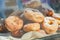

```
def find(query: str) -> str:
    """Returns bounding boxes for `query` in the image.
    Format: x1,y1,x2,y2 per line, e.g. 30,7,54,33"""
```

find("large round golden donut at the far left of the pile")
5,16,23,32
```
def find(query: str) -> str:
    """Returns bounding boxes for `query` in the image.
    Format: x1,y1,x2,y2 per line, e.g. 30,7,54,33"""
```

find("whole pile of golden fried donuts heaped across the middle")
5,8,60,37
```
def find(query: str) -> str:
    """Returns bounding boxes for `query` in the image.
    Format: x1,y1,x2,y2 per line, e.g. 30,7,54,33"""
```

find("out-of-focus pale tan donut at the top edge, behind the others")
24,0,41,8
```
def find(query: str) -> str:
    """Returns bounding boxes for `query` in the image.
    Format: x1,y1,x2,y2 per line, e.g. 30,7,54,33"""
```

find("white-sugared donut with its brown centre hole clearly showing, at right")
42,17,58,34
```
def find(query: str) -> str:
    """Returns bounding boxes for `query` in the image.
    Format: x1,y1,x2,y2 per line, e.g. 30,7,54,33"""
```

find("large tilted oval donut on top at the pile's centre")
24,8,44,23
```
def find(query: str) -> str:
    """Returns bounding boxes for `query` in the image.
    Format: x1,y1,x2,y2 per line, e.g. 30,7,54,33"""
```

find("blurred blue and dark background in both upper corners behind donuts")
0,0,60,18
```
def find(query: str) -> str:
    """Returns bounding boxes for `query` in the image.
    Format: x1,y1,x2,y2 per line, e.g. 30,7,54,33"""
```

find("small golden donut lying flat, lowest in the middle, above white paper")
23,23,40,32
